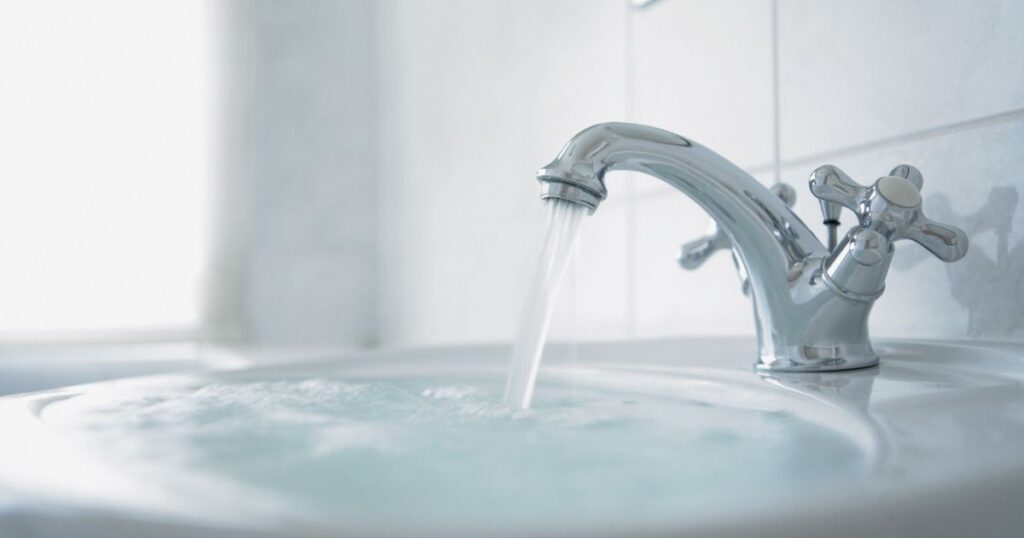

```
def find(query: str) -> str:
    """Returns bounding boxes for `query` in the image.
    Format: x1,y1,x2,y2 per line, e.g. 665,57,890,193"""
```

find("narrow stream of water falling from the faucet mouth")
505,200,587,409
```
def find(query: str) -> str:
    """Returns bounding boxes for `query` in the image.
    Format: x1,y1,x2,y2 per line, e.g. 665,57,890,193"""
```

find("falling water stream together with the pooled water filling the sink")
6,189,868,536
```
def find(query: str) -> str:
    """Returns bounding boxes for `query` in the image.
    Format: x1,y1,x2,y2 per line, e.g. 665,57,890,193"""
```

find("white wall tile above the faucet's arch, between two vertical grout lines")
631,0,773,192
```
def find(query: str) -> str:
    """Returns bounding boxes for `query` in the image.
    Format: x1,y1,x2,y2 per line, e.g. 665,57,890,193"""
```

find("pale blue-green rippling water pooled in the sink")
28,368,864,534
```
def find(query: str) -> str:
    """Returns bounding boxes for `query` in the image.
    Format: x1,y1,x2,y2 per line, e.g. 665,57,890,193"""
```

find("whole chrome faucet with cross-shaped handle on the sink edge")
537,123,968,372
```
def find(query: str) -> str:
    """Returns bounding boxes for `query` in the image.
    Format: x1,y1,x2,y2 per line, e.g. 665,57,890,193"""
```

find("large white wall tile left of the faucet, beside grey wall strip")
380,0,627,344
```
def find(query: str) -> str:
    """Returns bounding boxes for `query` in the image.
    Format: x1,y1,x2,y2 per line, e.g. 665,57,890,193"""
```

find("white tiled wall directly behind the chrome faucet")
378,0,1024,345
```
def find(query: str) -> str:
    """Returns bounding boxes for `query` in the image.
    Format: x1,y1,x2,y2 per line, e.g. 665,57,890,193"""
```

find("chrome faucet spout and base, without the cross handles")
537,123,878,371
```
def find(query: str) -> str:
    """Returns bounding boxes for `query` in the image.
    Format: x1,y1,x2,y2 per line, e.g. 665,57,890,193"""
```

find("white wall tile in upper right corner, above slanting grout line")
778,0,1024,160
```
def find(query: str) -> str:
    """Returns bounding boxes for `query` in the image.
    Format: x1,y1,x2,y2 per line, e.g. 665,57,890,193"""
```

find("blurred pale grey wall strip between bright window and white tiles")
214,0,378,345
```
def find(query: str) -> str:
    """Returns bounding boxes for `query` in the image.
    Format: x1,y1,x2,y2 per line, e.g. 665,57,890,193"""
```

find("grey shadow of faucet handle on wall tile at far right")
893,187,1024,338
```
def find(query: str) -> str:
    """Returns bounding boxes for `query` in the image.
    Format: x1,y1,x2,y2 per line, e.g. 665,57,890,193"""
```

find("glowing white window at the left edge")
0,0,214,339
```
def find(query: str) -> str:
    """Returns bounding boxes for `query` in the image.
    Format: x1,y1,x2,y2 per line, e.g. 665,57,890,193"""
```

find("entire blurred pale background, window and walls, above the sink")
0,0,1024,358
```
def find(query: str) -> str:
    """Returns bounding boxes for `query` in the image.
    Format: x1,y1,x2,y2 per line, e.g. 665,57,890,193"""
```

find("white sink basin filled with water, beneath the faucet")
0,339,1024,536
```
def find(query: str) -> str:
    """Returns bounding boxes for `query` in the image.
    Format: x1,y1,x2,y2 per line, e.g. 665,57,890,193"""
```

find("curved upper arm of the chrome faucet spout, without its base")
538,123,827,291
